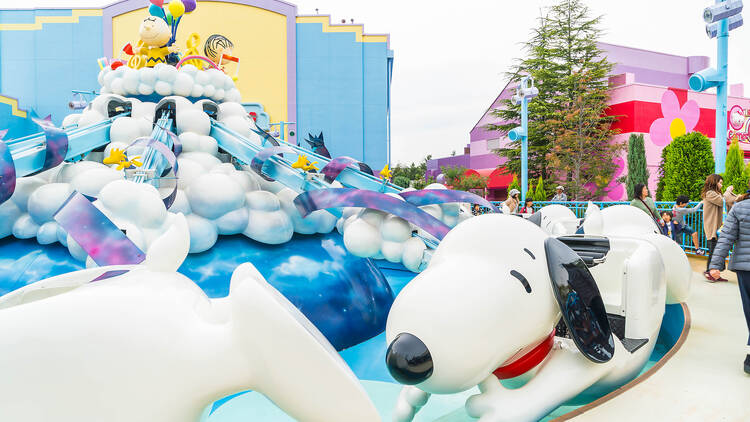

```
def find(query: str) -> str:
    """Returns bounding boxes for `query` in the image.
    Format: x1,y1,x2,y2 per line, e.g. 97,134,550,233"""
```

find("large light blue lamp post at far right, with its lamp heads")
688,0,743,174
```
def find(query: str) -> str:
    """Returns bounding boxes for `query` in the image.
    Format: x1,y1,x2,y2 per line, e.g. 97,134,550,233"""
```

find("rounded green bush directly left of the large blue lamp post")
660,132,714,201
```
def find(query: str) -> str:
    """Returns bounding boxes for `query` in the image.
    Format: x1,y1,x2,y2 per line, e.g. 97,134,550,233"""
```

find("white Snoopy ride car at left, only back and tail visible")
0,214,380,422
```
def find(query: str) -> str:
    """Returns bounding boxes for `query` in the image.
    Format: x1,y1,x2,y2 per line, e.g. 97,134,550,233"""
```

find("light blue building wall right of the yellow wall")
297,23,390,170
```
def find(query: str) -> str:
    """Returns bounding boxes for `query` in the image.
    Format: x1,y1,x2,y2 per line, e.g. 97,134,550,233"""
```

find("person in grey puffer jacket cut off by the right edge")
708,190,750,374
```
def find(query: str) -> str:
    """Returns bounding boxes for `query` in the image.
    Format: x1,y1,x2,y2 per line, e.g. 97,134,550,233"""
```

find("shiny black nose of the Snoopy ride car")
385,333,433,385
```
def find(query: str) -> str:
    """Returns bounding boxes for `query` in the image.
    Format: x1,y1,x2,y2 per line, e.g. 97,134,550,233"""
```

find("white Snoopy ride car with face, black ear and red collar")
386,207,690,422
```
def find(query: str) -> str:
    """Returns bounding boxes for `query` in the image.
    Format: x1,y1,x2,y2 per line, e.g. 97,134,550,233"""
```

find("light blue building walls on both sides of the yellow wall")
0,9,392,170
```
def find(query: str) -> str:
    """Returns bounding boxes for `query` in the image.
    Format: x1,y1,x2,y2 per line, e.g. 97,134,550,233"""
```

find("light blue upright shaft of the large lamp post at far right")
714,11,729,174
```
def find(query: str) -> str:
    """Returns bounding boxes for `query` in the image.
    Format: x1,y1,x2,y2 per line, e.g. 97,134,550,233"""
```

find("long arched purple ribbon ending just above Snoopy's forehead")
294,188,450,240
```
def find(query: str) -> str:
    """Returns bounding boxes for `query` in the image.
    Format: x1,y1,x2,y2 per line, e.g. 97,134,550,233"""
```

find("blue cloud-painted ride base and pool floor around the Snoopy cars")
0,233,684,422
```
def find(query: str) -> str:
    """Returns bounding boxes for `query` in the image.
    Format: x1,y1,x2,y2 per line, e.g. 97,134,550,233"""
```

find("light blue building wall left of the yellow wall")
0,9,103,136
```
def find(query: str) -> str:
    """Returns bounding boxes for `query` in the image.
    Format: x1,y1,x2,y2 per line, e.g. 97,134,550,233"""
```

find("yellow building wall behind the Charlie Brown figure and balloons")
112,1,288,122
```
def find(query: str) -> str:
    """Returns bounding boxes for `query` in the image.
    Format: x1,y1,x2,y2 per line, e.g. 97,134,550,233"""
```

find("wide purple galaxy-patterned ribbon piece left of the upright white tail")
55,192,146,266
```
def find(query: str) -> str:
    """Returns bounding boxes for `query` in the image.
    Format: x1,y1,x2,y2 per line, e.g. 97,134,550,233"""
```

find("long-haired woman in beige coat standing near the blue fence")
701,174,737,283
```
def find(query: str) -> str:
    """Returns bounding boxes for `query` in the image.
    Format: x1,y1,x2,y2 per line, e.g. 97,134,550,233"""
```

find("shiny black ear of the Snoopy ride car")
544,237,615,363
